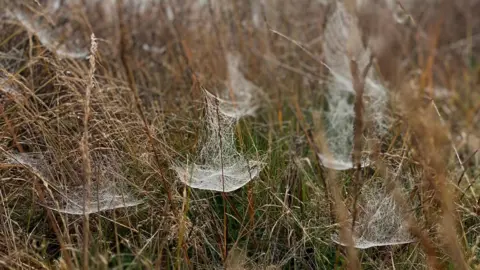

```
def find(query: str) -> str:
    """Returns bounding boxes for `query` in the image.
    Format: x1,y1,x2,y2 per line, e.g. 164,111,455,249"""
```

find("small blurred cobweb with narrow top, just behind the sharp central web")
217,53,259,119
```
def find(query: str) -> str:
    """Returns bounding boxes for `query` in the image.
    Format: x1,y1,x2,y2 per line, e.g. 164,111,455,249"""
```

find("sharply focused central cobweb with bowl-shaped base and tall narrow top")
173,91,265,192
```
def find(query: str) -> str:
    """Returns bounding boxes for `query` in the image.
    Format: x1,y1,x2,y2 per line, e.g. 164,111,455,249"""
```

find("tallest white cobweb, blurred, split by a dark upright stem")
319,2,387,170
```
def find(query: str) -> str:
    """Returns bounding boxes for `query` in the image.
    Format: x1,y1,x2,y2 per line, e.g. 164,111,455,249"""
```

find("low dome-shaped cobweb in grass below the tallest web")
332,183,416,249
